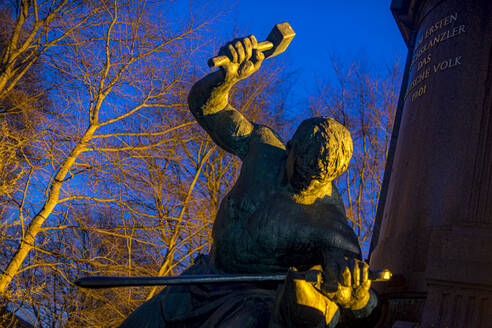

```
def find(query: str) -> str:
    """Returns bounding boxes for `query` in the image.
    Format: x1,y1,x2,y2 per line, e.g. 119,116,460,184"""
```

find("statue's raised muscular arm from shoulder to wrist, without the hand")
188,70,253,159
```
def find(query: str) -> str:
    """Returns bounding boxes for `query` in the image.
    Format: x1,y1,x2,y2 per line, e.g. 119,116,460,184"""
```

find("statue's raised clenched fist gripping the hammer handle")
219,35,265,83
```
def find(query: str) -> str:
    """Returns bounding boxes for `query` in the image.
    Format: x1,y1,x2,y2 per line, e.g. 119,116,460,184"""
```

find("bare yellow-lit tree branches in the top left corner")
0,0,104,99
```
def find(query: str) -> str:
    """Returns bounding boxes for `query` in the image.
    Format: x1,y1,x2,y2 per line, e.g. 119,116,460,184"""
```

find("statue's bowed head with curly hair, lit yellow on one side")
286,117,353,192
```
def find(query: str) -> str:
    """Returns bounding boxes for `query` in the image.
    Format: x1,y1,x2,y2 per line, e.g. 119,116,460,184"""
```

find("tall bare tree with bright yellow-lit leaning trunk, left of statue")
0,1,212,293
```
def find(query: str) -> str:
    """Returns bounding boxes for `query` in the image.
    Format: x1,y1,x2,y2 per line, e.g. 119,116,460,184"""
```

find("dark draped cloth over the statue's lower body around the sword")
120,255,277,328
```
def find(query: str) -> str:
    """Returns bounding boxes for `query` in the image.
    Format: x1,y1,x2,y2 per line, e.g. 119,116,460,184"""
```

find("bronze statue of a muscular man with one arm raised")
121,26,377,328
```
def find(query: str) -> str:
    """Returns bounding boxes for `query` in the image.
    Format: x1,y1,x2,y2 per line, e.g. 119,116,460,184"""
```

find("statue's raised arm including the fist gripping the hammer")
188,35,264,159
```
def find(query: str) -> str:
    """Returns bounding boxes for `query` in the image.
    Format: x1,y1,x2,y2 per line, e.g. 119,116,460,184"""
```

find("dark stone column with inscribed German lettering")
371,0,492,327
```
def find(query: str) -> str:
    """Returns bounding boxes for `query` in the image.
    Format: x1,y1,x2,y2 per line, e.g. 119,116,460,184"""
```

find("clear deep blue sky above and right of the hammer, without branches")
193,0,407,105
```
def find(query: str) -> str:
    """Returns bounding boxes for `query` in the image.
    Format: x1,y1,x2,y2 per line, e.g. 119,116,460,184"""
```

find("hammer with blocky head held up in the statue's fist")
208,22,296,68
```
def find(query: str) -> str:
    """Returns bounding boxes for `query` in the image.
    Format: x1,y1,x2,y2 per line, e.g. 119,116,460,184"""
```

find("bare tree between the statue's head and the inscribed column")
310,59,401,250
